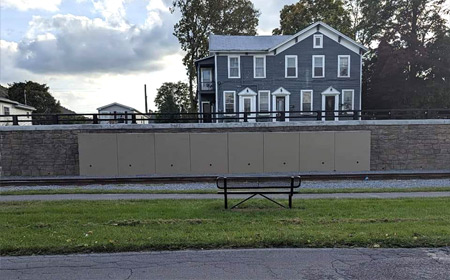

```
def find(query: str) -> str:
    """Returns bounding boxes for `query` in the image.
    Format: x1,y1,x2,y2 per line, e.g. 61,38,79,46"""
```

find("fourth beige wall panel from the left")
190,133,228,174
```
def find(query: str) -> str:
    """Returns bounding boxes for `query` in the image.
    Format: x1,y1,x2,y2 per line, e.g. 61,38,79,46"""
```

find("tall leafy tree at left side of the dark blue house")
172,0,260,112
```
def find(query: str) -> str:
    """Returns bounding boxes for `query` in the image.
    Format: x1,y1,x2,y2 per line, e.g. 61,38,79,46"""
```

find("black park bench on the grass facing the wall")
216,176,302,209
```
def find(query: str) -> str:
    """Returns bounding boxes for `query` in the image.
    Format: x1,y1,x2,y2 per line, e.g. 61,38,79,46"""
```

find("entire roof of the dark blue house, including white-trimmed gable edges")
209,21,368,52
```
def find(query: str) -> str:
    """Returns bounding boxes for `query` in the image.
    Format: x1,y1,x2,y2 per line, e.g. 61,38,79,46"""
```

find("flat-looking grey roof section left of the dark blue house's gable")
209,35,291,52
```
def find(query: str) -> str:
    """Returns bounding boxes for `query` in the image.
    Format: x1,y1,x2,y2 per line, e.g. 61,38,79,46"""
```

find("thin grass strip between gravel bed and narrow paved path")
0,186,450,195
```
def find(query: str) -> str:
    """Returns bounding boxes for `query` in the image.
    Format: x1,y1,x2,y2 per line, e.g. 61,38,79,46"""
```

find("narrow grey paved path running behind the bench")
0,192,450,202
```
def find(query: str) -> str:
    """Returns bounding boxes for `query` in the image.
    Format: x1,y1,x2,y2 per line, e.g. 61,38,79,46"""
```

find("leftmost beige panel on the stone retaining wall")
78,133,118,176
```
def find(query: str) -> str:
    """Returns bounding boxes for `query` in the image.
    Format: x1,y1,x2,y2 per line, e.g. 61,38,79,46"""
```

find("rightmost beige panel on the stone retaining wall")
334,131,370,172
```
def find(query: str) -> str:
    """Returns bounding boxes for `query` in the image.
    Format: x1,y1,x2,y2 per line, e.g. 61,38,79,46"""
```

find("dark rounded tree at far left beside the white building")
8,81,61,114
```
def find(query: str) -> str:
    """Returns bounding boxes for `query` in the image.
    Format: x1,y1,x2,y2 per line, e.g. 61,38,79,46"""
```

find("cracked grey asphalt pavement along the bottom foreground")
0,248,450,280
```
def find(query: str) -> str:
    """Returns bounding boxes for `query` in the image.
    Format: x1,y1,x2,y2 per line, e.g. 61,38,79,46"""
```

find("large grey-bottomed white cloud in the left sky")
17,0,180,74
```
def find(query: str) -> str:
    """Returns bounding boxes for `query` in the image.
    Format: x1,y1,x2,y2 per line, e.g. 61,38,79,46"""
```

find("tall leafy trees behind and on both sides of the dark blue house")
160,0,450,112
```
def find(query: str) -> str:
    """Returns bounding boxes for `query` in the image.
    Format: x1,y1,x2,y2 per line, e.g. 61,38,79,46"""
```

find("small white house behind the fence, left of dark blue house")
97,102,149,124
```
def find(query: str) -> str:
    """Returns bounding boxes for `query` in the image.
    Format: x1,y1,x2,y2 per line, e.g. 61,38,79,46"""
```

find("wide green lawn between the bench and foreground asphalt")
0,198,450,255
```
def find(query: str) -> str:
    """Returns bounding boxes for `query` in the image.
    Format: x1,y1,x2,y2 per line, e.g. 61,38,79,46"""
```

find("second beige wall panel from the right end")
300,131,334,171
